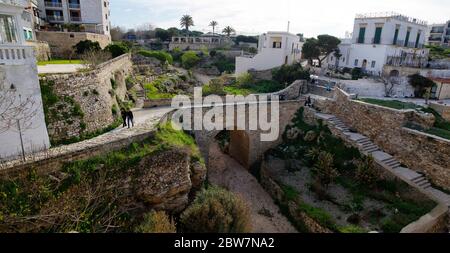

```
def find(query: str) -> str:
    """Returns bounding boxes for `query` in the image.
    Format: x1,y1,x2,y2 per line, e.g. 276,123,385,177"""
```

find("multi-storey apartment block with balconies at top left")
38,0,111,35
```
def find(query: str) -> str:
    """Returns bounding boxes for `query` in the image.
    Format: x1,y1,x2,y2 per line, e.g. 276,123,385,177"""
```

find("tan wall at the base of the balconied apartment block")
36,31,111,58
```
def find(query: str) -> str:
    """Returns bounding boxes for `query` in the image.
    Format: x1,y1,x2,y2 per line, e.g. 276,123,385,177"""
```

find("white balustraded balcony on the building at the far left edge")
0,44,35,65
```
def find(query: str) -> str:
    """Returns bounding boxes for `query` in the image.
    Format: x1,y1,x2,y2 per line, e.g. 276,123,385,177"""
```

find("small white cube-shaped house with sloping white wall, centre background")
236,32,303,75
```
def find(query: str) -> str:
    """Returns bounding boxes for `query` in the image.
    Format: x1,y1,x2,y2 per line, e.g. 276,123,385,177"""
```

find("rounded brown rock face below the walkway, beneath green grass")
134,151,193,212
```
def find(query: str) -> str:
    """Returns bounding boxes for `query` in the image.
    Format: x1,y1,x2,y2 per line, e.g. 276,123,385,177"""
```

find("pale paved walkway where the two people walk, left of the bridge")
0,107,172,170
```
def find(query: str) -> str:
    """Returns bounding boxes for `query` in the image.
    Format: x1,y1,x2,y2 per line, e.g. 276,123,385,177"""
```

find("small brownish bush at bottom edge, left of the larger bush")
135,211,177,233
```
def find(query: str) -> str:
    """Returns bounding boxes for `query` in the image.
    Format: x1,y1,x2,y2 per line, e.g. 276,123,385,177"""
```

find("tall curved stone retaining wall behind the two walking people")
41,55,132,141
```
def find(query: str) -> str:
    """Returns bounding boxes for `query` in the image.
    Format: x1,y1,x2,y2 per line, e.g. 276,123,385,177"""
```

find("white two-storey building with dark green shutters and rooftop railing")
327,13,429,75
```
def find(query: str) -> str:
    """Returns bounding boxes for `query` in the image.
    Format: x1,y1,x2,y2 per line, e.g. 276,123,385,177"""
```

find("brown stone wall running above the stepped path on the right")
321,89,450,189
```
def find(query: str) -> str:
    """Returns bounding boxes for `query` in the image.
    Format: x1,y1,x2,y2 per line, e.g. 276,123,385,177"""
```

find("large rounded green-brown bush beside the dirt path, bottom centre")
181,186,250,233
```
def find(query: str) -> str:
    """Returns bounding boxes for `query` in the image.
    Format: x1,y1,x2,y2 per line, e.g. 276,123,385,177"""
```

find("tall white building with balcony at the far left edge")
0,0,50,160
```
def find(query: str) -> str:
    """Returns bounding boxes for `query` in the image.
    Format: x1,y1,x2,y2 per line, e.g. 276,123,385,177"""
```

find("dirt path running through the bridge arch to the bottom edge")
208,143,297,233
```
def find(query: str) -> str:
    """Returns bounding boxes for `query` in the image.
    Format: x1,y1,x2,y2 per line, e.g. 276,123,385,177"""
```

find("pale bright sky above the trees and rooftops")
110,0,450,37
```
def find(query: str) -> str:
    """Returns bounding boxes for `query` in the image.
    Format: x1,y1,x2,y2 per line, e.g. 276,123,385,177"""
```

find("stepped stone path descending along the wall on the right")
316,110,450,206
